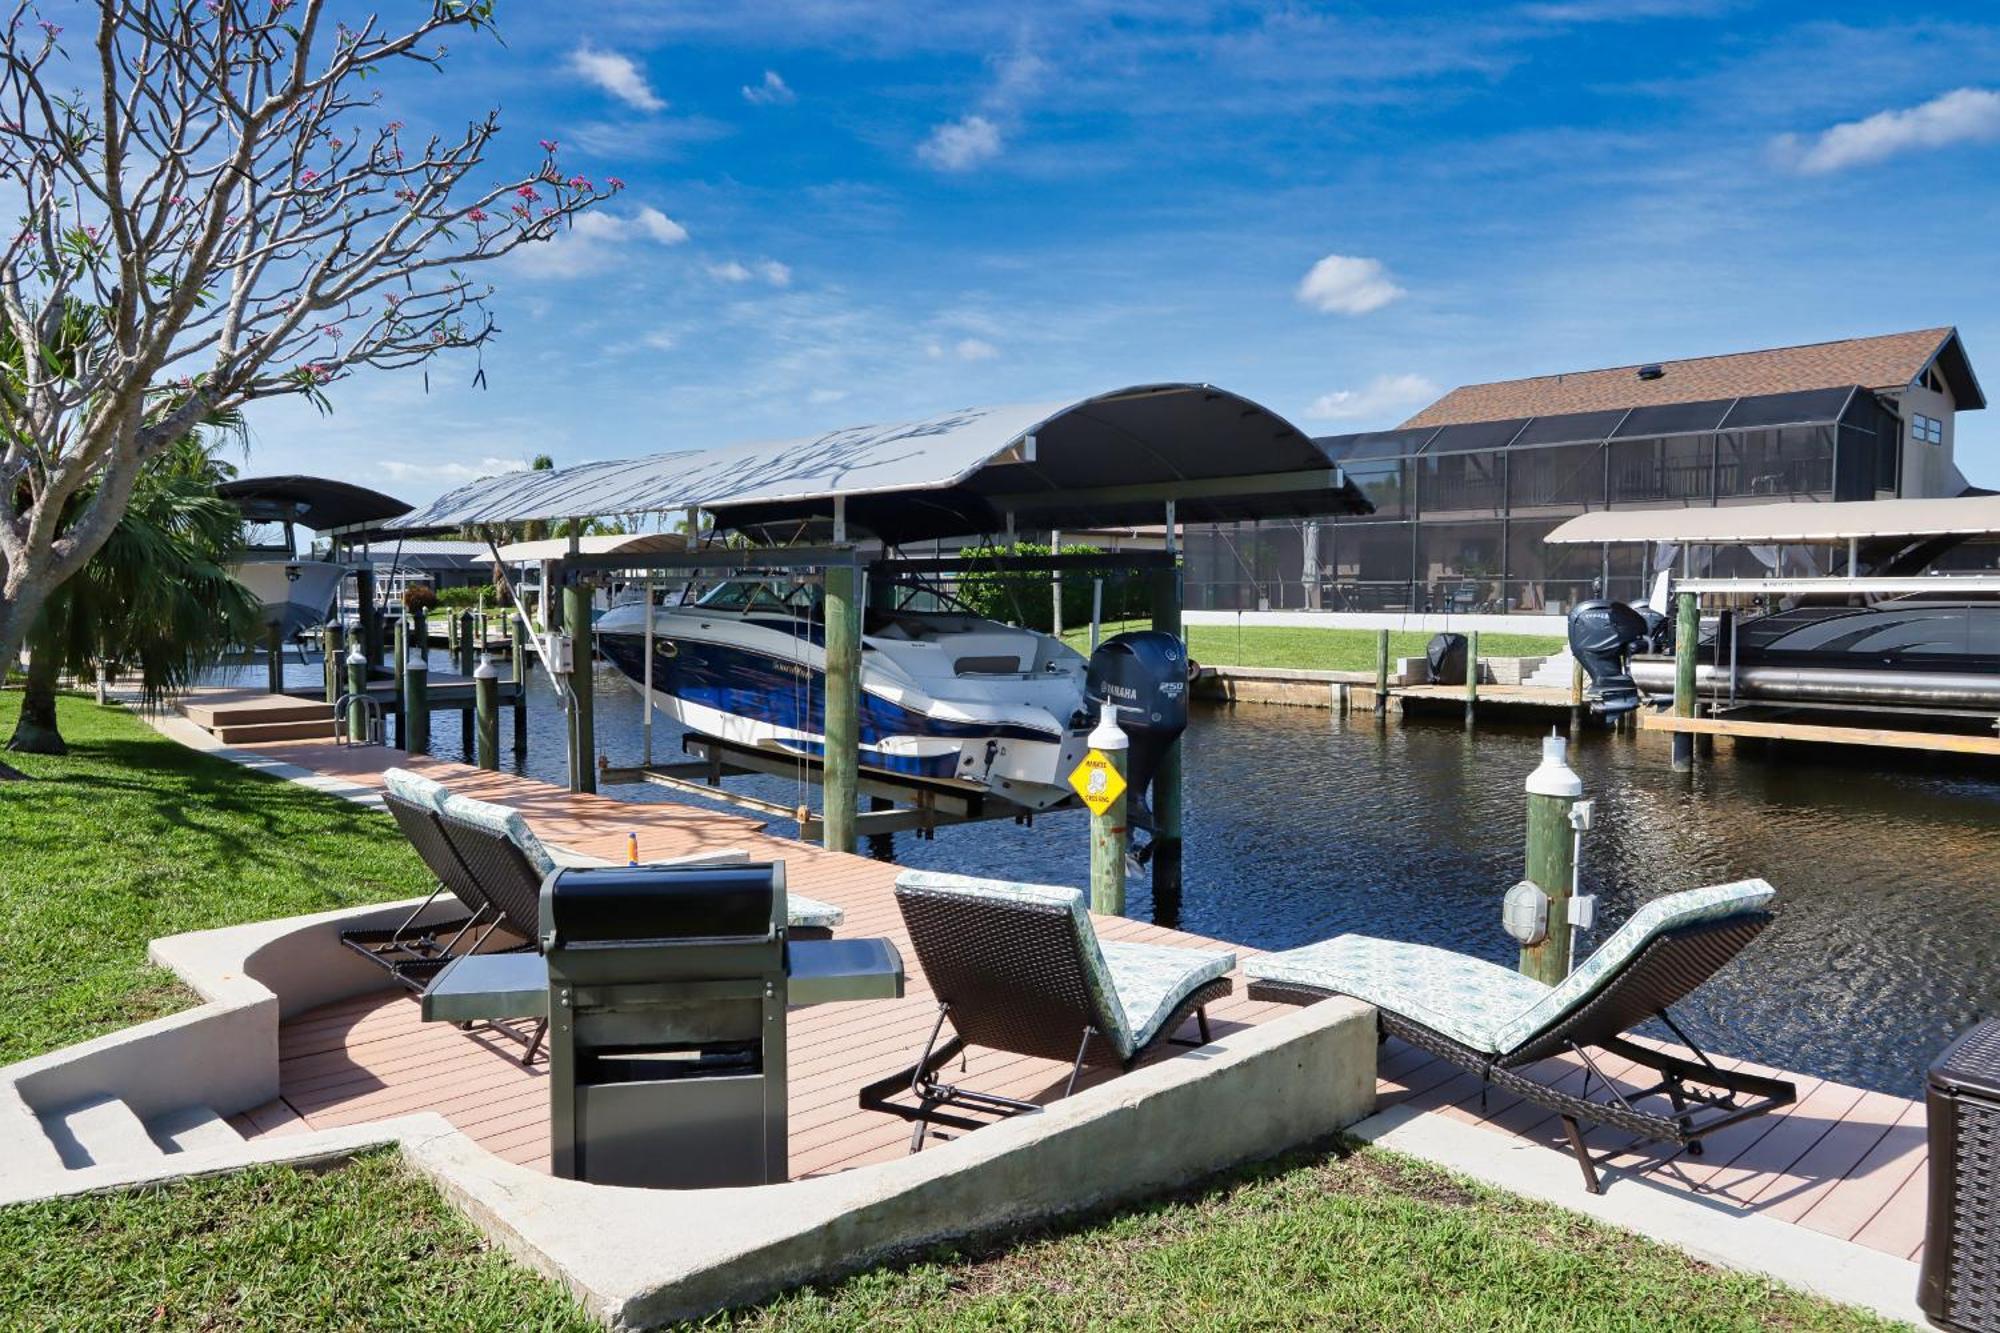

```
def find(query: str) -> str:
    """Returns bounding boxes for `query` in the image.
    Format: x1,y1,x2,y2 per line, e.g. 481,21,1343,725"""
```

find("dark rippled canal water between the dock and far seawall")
246,656,2000,1097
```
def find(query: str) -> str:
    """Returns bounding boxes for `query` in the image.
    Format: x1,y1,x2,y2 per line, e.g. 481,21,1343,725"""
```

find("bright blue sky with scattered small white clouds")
242,0,2000,500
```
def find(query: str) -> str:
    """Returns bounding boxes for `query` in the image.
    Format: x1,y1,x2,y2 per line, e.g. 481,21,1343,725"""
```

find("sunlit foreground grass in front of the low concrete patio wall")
0,1147,1888,1333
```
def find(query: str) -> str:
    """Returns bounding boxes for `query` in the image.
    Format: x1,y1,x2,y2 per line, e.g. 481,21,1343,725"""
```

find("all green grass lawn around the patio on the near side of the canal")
0,688,1880,1333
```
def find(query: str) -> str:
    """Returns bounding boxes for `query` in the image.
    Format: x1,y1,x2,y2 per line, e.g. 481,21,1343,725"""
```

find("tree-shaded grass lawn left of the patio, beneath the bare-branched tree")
0,691,430,1063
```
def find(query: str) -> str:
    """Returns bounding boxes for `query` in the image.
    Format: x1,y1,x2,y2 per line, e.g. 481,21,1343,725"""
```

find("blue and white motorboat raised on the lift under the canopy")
596,578,1092,811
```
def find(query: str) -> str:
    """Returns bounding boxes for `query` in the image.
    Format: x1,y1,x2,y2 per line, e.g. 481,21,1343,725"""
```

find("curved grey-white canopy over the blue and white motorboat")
382,384,1370,542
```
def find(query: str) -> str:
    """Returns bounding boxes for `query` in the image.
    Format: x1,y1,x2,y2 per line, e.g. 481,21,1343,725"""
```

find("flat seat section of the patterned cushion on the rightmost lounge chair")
1244,935,1550,1053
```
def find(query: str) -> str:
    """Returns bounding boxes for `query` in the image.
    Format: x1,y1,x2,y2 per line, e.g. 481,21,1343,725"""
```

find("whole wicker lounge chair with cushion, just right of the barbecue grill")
860,871,1236,1153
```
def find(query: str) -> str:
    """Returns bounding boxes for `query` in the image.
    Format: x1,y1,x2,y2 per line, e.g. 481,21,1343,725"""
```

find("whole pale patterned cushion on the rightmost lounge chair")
1244,879,1776,1055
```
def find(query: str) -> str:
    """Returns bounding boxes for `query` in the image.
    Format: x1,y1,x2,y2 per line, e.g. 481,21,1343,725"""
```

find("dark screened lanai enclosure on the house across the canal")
1186,386,1902,614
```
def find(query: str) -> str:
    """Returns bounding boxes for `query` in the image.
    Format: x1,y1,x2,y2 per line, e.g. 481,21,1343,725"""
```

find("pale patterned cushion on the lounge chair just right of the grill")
896,871,1236,1059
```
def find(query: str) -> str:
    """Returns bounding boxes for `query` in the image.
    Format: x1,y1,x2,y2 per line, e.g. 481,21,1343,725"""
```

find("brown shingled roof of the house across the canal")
1402,328,1954,428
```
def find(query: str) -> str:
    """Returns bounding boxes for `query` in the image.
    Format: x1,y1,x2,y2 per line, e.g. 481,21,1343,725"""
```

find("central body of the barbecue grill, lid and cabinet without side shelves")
540,863,790,1189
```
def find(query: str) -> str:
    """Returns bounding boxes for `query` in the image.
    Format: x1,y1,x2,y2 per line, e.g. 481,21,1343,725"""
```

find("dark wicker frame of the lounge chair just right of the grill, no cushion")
860,887,1232,1153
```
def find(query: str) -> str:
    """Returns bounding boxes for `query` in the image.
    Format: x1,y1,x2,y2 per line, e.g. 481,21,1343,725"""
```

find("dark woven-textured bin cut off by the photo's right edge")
1916,1019,2000,1333
